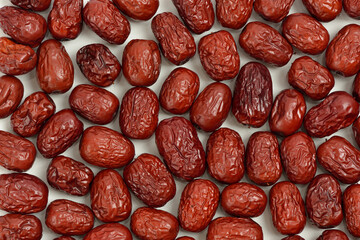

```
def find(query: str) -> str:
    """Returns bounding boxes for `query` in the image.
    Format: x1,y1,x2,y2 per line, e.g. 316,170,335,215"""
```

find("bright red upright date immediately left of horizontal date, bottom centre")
178,179,220,232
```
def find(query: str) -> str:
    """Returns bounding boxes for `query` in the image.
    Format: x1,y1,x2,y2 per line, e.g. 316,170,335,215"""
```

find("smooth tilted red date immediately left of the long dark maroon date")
190,82,231,132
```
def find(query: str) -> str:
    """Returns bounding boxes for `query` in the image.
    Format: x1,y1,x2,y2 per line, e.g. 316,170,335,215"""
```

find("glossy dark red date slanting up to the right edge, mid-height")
304,91,359,138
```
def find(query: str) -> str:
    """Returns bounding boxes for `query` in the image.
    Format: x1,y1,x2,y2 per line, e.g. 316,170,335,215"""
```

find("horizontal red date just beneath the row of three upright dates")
220,182,267,217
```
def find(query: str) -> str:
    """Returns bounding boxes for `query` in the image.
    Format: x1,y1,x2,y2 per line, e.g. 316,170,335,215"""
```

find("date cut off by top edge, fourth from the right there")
216,0,254,29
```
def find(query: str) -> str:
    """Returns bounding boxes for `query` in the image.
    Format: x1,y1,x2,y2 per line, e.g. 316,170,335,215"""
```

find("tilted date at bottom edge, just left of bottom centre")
130,207,179,240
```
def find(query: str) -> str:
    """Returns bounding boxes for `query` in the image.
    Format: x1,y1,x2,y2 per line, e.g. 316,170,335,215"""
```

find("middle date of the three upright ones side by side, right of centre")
245,132,282,186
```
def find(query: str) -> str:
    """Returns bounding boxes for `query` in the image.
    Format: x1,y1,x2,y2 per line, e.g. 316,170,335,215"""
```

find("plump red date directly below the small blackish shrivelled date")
69,84,119,125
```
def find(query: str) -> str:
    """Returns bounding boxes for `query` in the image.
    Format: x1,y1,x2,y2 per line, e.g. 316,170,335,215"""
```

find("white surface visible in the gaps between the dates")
0,0,360,240
